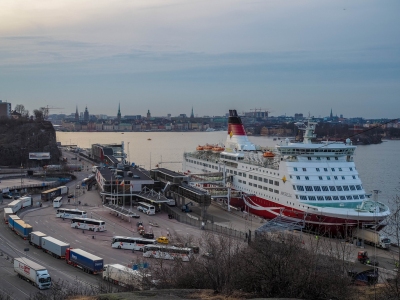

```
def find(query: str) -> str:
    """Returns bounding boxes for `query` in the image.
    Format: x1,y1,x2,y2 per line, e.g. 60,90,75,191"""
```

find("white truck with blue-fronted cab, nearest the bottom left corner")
14,257,51,290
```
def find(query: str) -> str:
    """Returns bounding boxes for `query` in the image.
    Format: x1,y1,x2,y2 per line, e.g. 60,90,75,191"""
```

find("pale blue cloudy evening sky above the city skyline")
0,0,400,119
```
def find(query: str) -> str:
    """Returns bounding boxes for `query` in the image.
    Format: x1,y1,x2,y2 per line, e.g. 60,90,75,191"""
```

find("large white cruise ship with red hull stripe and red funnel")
183,110,390,234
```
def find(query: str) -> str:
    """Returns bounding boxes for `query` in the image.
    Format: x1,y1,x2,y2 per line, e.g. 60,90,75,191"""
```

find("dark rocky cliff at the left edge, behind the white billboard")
0,119,61,168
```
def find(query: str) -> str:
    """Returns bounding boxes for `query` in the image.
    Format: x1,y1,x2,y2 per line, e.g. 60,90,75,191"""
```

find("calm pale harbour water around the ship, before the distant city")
57,131,400,204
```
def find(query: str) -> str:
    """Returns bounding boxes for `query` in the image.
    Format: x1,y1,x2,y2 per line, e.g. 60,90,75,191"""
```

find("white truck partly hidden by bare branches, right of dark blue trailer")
103,264,150,290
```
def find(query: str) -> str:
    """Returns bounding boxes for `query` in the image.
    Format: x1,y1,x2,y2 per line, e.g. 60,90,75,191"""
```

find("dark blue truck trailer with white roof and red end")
65,248,104,274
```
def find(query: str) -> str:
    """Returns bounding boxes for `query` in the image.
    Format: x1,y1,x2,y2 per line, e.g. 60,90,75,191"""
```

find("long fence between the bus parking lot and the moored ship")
163,205,246,239
